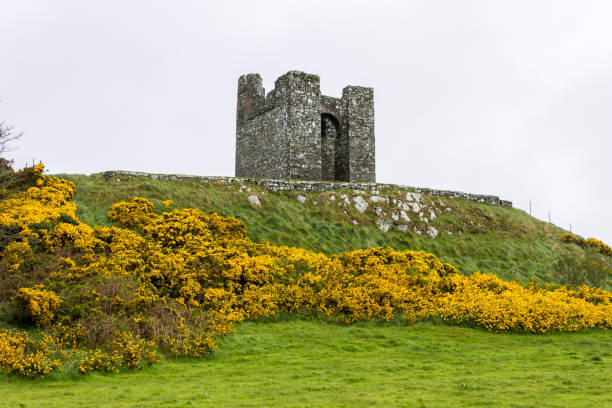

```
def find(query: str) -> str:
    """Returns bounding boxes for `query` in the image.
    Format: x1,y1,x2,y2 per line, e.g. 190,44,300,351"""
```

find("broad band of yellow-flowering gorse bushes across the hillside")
0,167,612,375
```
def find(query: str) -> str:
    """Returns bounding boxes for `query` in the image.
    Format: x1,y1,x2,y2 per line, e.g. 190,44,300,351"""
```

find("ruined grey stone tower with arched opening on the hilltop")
236,71,376,182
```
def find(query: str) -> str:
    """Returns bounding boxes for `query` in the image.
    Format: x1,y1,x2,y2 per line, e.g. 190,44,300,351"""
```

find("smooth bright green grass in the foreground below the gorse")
0,320,612,408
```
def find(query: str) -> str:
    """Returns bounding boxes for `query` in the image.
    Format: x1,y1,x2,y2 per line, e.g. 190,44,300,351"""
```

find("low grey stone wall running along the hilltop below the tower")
103,170,512,207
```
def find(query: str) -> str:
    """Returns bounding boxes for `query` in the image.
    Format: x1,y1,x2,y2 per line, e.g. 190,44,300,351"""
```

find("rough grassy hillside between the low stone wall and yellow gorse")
62,174,609,283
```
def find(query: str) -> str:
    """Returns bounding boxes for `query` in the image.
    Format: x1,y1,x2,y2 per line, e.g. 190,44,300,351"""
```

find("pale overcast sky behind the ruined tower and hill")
0,0,612,244
